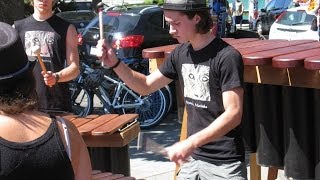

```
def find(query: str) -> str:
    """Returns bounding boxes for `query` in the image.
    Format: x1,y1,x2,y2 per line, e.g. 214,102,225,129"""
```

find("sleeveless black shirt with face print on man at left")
14,15,72,112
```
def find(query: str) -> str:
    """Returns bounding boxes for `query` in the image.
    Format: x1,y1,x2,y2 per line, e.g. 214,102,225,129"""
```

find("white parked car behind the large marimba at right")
269,7,319,40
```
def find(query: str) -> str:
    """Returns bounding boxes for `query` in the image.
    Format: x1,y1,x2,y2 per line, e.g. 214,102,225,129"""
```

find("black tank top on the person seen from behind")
0,118,74,180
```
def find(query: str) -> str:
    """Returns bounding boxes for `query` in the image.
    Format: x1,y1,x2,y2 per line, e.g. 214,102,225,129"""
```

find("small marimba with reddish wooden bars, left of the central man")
61,114,140,176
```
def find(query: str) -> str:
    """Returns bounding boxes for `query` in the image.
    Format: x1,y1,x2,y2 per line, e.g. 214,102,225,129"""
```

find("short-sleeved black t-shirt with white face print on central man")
159,38,244,162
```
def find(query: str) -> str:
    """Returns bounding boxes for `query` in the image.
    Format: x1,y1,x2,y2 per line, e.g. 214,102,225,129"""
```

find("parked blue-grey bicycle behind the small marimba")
70,63,172,128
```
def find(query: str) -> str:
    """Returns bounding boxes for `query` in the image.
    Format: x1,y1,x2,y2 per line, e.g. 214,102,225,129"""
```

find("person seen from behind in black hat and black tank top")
0,22,92,180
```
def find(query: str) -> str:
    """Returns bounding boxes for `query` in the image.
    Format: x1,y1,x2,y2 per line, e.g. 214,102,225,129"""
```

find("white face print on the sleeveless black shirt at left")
25,31,54,57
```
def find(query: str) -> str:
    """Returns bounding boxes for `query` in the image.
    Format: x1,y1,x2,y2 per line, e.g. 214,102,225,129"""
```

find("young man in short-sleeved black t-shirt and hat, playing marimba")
97,0,247,180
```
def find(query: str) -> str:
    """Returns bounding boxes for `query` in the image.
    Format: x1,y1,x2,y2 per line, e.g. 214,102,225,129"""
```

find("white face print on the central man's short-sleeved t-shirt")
181,64,211,101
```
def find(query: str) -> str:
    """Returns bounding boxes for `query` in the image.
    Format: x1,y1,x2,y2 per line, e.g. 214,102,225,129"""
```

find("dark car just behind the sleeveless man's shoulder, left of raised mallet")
57,10,96,33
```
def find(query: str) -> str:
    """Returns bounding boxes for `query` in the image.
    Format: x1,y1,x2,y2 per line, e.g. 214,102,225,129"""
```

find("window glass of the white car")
277,11,315,26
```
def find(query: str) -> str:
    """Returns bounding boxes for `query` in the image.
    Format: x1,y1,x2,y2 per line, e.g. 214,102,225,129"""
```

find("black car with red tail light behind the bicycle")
79,5,177,63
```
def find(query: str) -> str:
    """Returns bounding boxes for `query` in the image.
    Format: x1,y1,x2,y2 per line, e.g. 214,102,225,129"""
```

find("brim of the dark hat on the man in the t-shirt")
161,3,210,11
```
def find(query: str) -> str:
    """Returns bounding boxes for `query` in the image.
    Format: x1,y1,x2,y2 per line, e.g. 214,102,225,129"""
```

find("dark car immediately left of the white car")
253,0,293,35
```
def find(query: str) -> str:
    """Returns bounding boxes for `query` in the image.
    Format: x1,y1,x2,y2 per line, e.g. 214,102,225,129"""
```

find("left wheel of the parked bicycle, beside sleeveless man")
69,83,93,117
